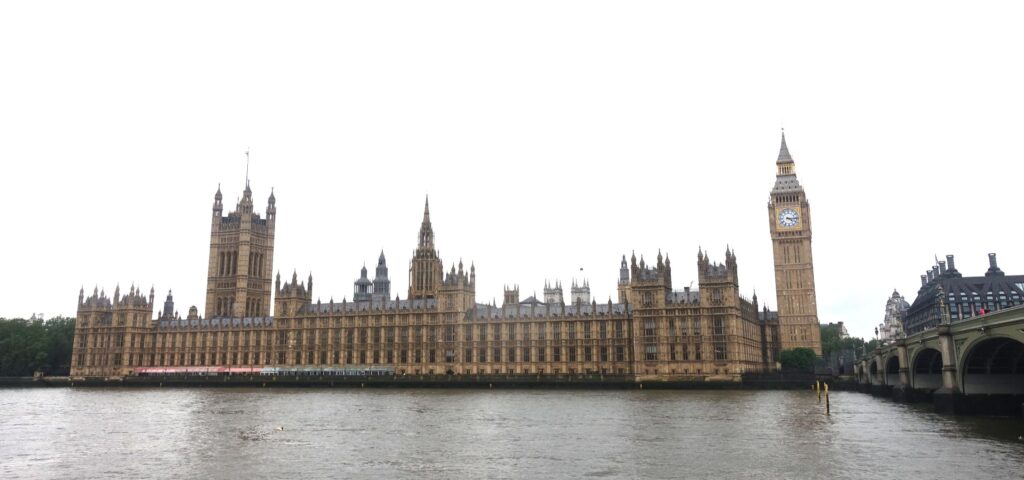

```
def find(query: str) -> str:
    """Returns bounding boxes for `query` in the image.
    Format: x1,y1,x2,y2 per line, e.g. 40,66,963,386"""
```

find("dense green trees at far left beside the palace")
0,317,75,377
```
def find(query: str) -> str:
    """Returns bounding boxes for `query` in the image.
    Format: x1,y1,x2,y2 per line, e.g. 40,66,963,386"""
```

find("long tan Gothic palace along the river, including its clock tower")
71,135,821,381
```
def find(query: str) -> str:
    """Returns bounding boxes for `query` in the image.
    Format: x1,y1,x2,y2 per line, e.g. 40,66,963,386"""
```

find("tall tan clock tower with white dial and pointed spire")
768,132,821,356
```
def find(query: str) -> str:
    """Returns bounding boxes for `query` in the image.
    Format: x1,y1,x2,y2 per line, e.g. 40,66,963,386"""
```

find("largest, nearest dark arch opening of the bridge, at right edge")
959,336,1024,395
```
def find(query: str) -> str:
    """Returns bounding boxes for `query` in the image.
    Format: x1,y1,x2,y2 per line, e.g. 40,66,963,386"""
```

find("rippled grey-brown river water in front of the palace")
0,388,1024,479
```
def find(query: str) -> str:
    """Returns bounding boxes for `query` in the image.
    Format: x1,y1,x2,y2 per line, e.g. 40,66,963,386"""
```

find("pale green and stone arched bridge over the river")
854,305,1024,416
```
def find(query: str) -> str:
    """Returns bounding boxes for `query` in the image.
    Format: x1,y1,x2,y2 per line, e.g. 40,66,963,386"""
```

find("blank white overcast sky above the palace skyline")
0,1,1024,337
